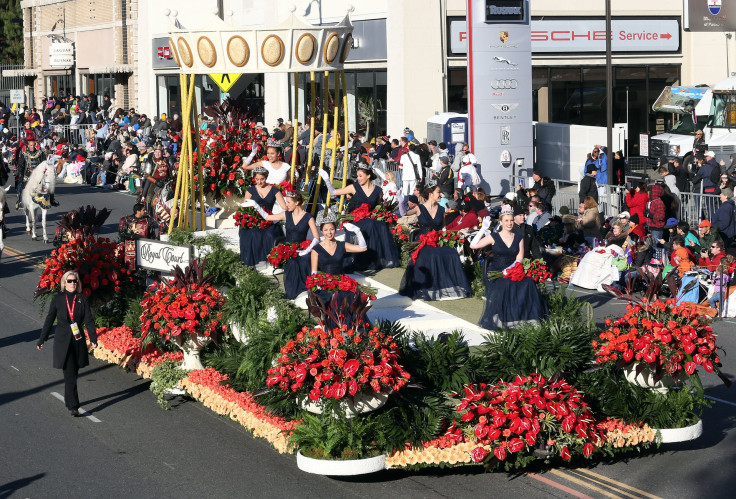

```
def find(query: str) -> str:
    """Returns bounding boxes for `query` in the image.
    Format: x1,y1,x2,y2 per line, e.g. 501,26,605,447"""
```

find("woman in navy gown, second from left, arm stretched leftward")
266,190,319,300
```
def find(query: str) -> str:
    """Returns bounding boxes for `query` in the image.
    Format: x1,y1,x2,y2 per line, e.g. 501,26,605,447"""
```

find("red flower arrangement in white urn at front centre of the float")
266,326,411,401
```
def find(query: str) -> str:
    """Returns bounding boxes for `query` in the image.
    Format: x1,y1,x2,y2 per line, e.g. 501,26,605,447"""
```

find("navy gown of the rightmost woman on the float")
478,232,547,329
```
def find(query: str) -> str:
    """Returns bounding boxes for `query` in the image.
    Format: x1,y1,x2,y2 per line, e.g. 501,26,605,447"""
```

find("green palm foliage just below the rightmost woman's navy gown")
479,291,594,382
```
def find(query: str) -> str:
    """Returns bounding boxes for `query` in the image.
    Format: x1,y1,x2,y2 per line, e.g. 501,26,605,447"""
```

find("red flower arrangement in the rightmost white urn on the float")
593,299,731,385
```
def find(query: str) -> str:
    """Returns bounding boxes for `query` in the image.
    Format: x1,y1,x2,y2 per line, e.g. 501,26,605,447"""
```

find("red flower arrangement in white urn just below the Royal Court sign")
140,260,227,346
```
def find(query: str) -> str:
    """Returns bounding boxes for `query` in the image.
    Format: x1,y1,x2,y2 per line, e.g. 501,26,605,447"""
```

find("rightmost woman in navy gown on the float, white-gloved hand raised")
470,207,547,329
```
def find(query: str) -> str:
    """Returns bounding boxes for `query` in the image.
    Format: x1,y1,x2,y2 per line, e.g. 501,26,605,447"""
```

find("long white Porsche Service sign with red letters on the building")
450,18,680,54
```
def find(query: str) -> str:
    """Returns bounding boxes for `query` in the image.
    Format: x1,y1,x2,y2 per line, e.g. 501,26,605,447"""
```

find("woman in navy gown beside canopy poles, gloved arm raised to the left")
320,163,401,271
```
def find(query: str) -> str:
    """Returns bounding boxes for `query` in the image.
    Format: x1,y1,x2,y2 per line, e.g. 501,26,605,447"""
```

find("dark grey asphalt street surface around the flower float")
0,185,736,498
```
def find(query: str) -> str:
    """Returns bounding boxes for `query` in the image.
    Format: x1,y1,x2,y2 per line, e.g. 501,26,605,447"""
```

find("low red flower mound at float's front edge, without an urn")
446,374,604,464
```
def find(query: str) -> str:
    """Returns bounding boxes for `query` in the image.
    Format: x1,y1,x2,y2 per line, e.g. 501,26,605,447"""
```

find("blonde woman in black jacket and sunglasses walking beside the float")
36,270,97,417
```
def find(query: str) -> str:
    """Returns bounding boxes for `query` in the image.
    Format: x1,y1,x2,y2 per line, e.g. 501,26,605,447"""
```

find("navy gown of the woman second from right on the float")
399,204,472,301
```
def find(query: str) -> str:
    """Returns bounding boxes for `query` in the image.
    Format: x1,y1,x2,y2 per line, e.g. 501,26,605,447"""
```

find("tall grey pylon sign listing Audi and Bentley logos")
467,0,533,195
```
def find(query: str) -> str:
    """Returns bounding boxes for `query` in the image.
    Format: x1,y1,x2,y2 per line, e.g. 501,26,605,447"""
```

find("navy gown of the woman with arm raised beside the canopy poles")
345,183,401,271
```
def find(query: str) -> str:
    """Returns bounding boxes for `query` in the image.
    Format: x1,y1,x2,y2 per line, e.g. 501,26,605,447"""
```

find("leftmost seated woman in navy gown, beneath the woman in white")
238,166,286,267
